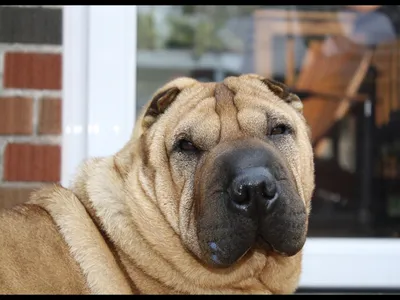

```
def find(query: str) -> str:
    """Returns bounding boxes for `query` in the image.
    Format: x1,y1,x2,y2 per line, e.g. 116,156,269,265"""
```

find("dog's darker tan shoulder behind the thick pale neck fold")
0,188,88,294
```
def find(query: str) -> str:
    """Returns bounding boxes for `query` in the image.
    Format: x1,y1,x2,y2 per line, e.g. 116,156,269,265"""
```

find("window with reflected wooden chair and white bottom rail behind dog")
136,5,400,287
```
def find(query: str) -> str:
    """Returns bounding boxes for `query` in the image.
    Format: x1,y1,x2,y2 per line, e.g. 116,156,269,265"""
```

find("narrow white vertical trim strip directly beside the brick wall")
61,5,89,186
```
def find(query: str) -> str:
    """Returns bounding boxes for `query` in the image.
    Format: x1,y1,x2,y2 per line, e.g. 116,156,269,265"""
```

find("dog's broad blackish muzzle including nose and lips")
196,142,307,266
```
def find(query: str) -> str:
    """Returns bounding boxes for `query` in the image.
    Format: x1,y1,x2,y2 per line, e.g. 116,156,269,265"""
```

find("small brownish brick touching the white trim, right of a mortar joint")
38,98,61,134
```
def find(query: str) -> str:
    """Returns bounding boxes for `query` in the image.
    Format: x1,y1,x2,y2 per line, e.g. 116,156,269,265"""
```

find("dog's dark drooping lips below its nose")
198,200,306,268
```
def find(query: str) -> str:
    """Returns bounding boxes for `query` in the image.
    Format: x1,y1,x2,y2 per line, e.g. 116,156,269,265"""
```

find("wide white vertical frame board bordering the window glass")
88,5,137,157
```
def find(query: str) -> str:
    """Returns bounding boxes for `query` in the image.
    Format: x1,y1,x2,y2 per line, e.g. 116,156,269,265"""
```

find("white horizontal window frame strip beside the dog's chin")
300,238,400,289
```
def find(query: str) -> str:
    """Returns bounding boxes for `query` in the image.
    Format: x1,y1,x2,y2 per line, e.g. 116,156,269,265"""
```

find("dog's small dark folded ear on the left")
142,87,181,128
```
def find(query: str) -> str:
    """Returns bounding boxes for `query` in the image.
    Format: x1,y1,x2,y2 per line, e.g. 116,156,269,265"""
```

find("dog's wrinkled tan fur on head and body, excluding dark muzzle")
0,75,314,294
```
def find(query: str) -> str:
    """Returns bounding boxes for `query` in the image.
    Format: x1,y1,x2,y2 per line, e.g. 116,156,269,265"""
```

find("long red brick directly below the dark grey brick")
3,52,61,90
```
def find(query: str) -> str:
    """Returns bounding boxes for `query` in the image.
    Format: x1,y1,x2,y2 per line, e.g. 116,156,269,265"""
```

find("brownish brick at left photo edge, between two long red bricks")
0,97,32,135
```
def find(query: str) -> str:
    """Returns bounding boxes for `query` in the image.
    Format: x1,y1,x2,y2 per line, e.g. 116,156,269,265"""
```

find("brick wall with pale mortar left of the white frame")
0,6,62,207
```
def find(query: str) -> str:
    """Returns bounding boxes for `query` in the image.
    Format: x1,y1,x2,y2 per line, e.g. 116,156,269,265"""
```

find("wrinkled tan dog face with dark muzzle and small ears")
141,75,314,267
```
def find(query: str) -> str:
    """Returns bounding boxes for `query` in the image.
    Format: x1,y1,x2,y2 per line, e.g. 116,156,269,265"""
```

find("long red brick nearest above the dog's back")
3,143,61,182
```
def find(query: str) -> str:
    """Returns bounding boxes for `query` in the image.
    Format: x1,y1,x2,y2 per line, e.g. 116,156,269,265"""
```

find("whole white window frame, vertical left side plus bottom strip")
61,5,400,288
